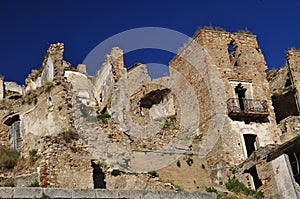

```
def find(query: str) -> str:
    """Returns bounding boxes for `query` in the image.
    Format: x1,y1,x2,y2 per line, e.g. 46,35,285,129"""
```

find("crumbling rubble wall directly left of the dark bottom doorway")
39,134,94,189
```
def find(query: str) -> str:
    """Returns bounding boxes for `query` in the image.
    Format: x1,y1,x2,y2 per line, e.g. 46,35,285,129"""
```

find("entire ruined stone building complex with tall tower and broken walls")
0,29,300,198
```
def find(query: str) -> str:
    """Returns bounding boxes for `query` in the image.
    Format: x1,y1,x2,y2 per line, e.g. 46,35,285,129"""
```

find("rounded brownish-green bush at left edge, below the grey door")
0,147,20,169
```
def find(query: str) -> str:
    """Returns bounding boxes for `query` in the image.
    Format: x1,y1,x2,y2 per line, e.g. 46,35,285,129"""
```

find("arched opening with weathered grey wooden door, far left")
4,115,22,151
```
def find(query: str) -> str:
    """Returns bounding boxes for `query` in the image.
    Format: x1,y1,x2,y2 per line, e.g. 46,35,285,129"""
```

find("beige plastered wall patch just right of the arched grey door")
20,83,70,138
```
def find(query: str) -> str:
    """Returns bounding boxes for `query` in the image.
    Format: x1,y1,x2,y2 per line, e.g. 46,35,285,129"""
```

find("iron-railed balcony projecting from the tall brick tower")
226,98,269,120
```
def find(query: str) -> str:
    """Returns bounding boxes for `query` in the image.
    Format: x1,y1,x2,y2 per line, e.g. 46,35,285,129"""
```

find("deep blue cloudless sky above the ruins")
0,0,300,84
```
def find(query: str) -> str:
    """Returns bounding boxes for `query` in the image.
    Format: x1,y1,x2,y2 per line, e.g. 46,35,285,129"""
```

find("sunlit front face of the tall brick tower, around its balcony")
182,29,280,188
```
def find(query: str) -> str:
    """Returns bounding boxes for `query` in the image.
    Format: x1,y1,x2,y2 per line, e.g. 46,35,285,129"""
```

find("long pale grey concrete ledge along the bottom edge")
0,187,217,199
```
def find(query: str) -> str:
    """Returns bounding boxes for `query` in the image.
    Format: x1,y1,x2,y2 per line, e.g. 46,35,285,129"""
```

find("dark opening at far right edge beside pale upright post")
286,145,300,184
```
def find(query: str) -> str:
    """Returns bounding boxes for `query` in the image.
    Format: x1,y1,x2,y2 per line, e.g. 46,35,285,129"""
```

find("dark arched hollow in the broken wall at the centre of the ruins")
140,88,171,109
